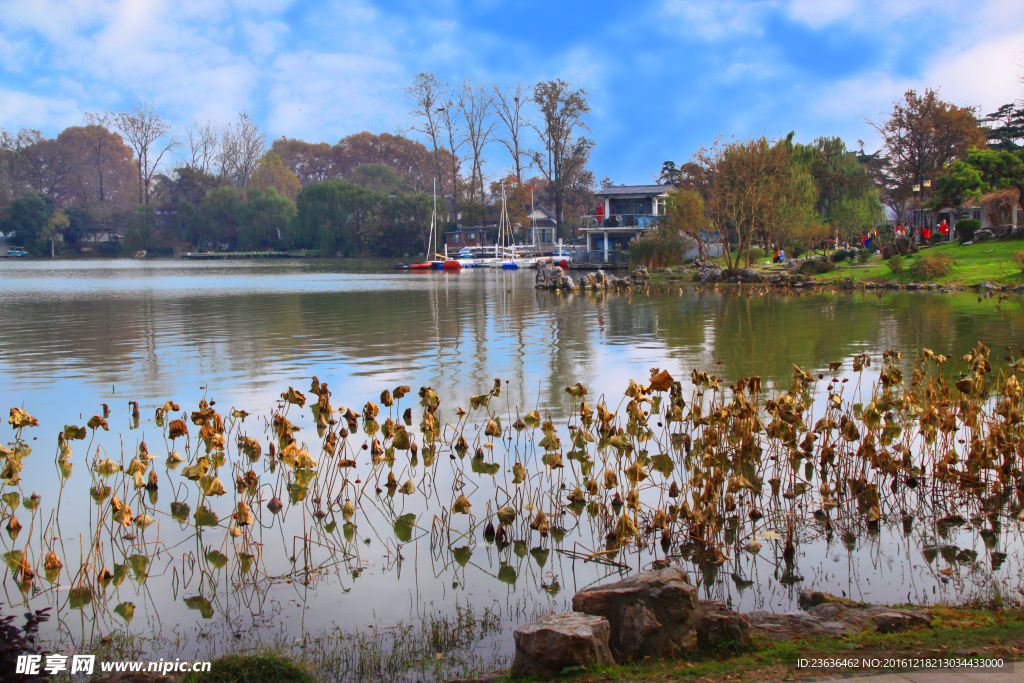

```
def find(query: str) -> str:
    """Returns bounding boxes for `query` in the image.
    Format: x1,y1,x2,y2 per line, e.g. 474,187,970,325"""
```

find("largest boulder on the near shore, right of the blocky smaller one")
572,567,698,658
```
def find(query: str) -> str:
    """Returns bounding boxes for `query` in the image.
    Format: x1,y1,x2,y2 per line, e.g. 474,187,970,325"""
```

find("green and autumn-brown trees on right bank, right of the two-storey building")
647,83,1024,271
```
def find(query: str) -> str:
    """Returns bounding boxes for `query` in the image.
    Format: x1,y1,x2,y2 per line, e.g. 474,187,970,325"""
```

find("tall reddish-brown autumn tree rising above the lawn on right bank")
868,88,985,213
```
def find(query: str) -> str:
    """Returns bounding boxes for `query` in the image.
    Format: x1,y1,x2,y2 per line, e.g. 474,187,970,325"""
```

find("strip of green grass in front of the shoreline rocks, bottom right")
528,607,1024,683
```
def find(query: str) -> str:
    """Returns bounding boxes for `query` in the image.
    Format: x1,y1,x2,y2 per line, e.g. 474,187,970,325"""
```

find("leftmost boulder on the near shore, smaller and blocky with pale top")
511,612,615,679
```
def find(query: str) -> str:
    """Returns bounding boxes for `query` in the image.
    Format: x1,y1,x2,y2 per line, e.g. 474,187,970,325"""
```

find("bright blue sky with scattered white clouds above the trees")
0,0,1024,183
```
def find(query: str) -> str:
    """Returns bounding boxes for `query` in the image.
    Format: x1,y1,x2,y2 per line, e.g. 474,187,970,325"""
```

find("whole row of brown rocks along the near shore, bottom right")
451,567,931,683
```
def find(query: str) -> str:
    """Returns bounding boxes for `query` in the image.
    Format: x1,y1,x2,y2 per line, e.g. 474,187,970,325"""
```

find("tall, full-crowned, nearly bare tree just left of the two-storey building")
529,79,594,238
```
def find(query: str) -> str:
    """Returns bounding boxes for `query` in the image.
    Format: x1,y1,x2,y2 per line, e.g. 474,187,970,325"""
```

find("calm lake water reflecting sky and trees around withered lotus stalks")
0,260,1024,679
